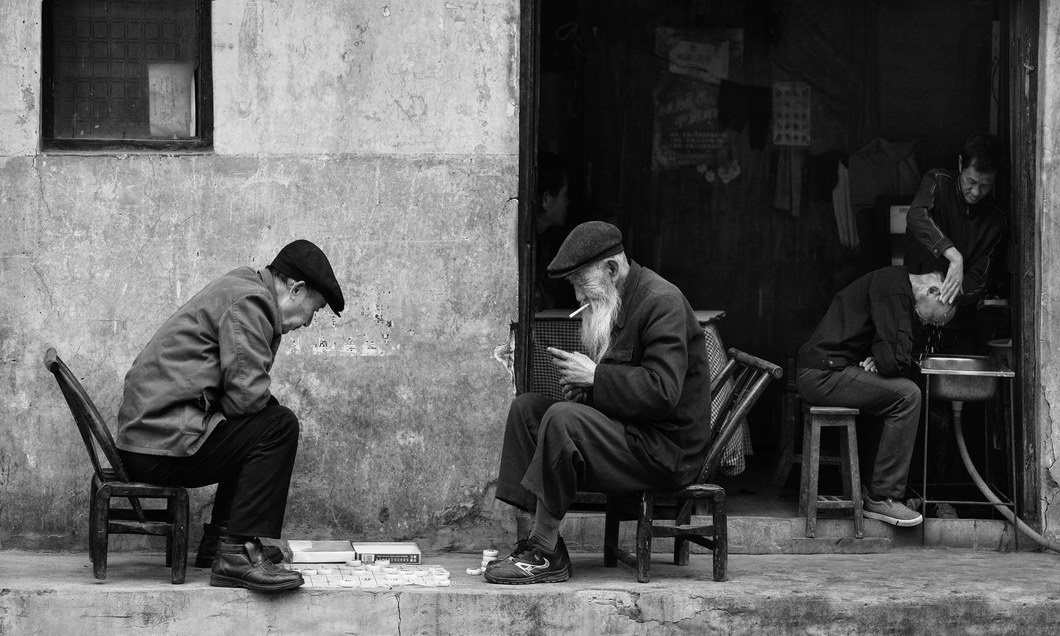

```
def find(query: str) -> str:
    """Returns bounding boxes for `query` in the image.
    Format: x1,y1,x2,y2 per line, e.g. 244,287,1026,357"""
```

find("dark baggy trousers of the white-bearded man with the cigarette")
497,393,673,517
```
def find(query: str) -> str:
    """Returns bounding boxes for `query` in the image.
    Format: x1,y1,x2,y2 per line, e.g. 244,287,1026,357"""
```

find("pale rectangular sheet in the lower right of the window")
147,61,195,139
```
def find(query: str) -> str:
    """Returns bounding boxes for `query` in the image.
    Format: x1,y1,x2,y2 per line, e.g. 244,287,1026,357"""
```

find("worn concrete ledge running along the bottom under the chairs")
0,550,1060,636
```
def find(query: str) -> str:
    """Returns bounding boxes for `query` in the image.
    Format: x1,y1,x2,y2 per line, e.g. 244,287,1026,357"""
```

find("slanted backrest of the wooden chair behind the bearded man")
697,349,784,483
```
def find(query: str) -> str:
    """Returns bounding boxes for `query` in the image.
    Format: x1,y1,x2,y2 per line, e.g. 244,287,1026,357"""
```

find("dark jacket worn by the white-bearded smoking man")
591,261,710,484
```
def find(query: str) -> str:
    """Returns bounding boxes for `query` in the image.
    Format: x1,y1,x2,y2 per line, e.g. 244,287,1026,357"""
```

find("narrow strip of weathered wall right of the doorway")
1037,2,1060,541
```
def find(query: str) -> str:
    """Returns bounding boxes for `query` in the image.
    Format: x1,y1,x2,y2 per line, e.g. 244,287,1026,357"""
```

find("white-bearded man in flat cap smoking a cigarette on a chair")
485,222,710,584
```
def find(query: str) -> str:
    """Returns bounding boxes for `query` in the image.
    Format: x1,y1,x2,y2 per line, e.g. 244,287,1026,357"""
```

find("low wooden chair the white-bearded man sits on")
571,349,783,583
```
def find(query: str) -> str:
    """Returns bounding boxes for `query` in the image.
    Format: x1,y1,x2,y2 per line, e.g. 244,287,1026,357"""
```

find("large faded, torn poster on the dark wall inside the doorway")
652,28,743,170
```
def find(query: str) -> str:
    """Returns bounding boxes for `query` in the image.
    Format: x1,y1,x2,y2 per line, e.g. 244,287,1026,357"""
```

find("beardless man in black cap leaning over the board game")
117,240,345,591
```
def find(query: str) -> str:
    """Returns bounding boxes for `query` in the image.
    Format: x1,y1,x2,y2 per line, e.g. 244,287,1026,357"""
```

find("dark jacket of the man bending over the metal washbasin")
798,265,917,377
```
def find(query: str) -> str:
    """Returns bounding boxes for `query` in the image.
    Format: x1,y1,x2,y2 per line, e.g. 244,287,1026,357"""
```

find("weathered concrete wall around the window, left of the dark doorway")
0,0,518,548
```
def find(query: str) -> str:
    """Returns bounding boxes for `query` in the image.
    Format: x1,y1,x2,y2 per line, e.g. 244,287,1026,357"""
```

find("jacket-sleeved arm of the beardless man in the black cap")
217,296,273,417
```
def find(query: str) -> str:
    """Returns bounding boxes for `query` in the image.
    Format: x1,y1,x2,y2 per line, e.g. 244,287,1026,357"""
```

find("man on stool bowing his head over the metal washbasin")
796,265,954,527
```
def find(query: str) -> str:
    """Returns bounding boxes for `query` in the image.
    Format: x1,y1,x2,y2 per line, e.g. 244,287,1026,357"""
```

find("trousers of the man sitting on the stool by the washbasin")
796,366,920,499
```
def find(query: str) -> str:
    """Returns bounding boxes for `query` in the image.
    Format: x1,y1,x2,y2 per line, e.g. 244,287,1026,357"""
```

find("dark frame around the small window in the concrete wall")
40,0,213,153
